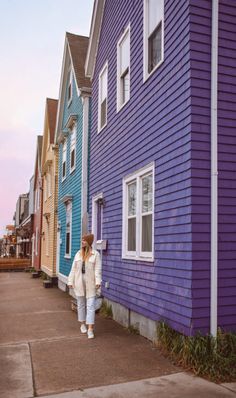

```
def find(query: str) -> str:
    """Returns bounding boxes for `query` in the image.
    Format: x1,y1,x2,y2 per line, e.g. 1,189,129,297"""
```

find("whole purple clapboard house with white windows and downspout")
85,0,236,339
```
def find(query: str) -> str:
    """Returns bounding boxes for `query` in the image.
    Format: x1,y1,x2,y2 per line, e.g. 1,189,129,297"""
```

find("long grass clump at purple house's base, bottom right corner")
157,322,236,383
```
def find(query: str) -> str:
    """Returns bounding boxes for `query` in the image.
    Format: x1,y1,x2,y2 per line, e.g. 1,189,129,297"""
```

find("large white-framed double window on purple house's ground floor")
123,165,154,261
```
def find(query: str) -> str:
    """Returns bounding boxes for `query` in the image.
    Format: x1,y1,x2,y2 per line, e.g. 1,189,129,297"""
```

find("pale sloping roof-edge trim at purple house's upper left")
85,0,106,80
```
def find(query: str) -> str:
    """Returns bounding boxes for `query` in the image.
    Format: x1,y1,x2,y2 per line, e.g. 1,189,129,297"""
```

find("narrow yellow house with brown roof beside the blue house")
41,98,58,278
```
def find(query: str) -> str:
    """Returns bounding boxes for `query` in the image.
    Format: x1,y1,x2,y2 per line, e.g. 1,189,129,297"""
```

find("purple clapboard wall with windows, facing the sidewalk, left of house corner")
89,0,194,333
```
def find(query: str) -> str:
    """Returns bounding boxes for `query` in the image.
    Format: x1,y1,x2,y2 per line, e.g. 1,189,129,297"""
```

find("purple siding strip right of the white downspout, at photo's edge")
218,0,236,330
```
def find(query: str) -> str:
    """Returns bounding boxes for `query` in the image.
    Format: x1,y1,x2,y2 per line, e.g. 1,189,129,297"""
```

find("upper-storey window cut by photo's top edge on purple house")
144,0,164,80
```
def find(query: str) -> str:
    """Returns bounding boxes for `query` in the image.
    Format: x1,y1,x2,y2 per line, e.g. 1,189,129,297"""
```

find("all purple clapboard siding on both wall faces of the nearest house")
89,0,236,334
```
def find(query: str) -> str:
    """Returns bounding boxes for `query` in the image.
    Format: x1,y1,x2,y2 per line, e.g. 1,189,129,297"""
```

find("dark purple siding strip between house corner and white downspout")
190,0,212,332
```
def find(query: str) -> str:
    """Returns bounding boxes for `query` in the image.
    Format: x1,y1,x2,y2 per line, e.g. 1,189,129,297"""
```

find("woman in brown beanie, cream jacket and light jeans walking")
68,234,101,339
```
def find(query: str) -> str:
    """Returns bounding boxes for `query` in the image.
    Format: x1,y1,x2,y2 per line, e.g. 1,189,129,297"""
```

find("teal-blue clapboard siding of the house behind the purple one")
58,72,83,276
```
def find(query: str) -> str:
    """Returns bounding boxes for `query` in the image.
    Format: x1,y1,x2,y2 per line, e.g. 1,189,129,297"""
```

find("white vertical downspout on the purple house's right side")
210,0,219,337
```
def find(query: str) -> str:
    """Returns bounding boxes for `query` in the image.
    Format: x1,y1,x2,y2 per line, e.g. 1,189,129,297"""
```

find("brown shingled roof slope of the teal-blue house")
66,32,91,88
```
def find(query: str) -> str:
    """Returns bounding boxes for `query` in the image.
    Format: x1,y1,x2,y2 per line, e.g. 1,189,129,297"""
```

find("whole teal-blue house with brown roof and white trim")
55,33,91,291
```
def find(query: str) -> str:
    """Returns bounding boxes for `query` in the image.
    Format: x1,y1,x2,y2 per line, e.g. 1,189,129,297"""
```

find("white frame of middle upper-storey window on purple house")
117,24,130,112
